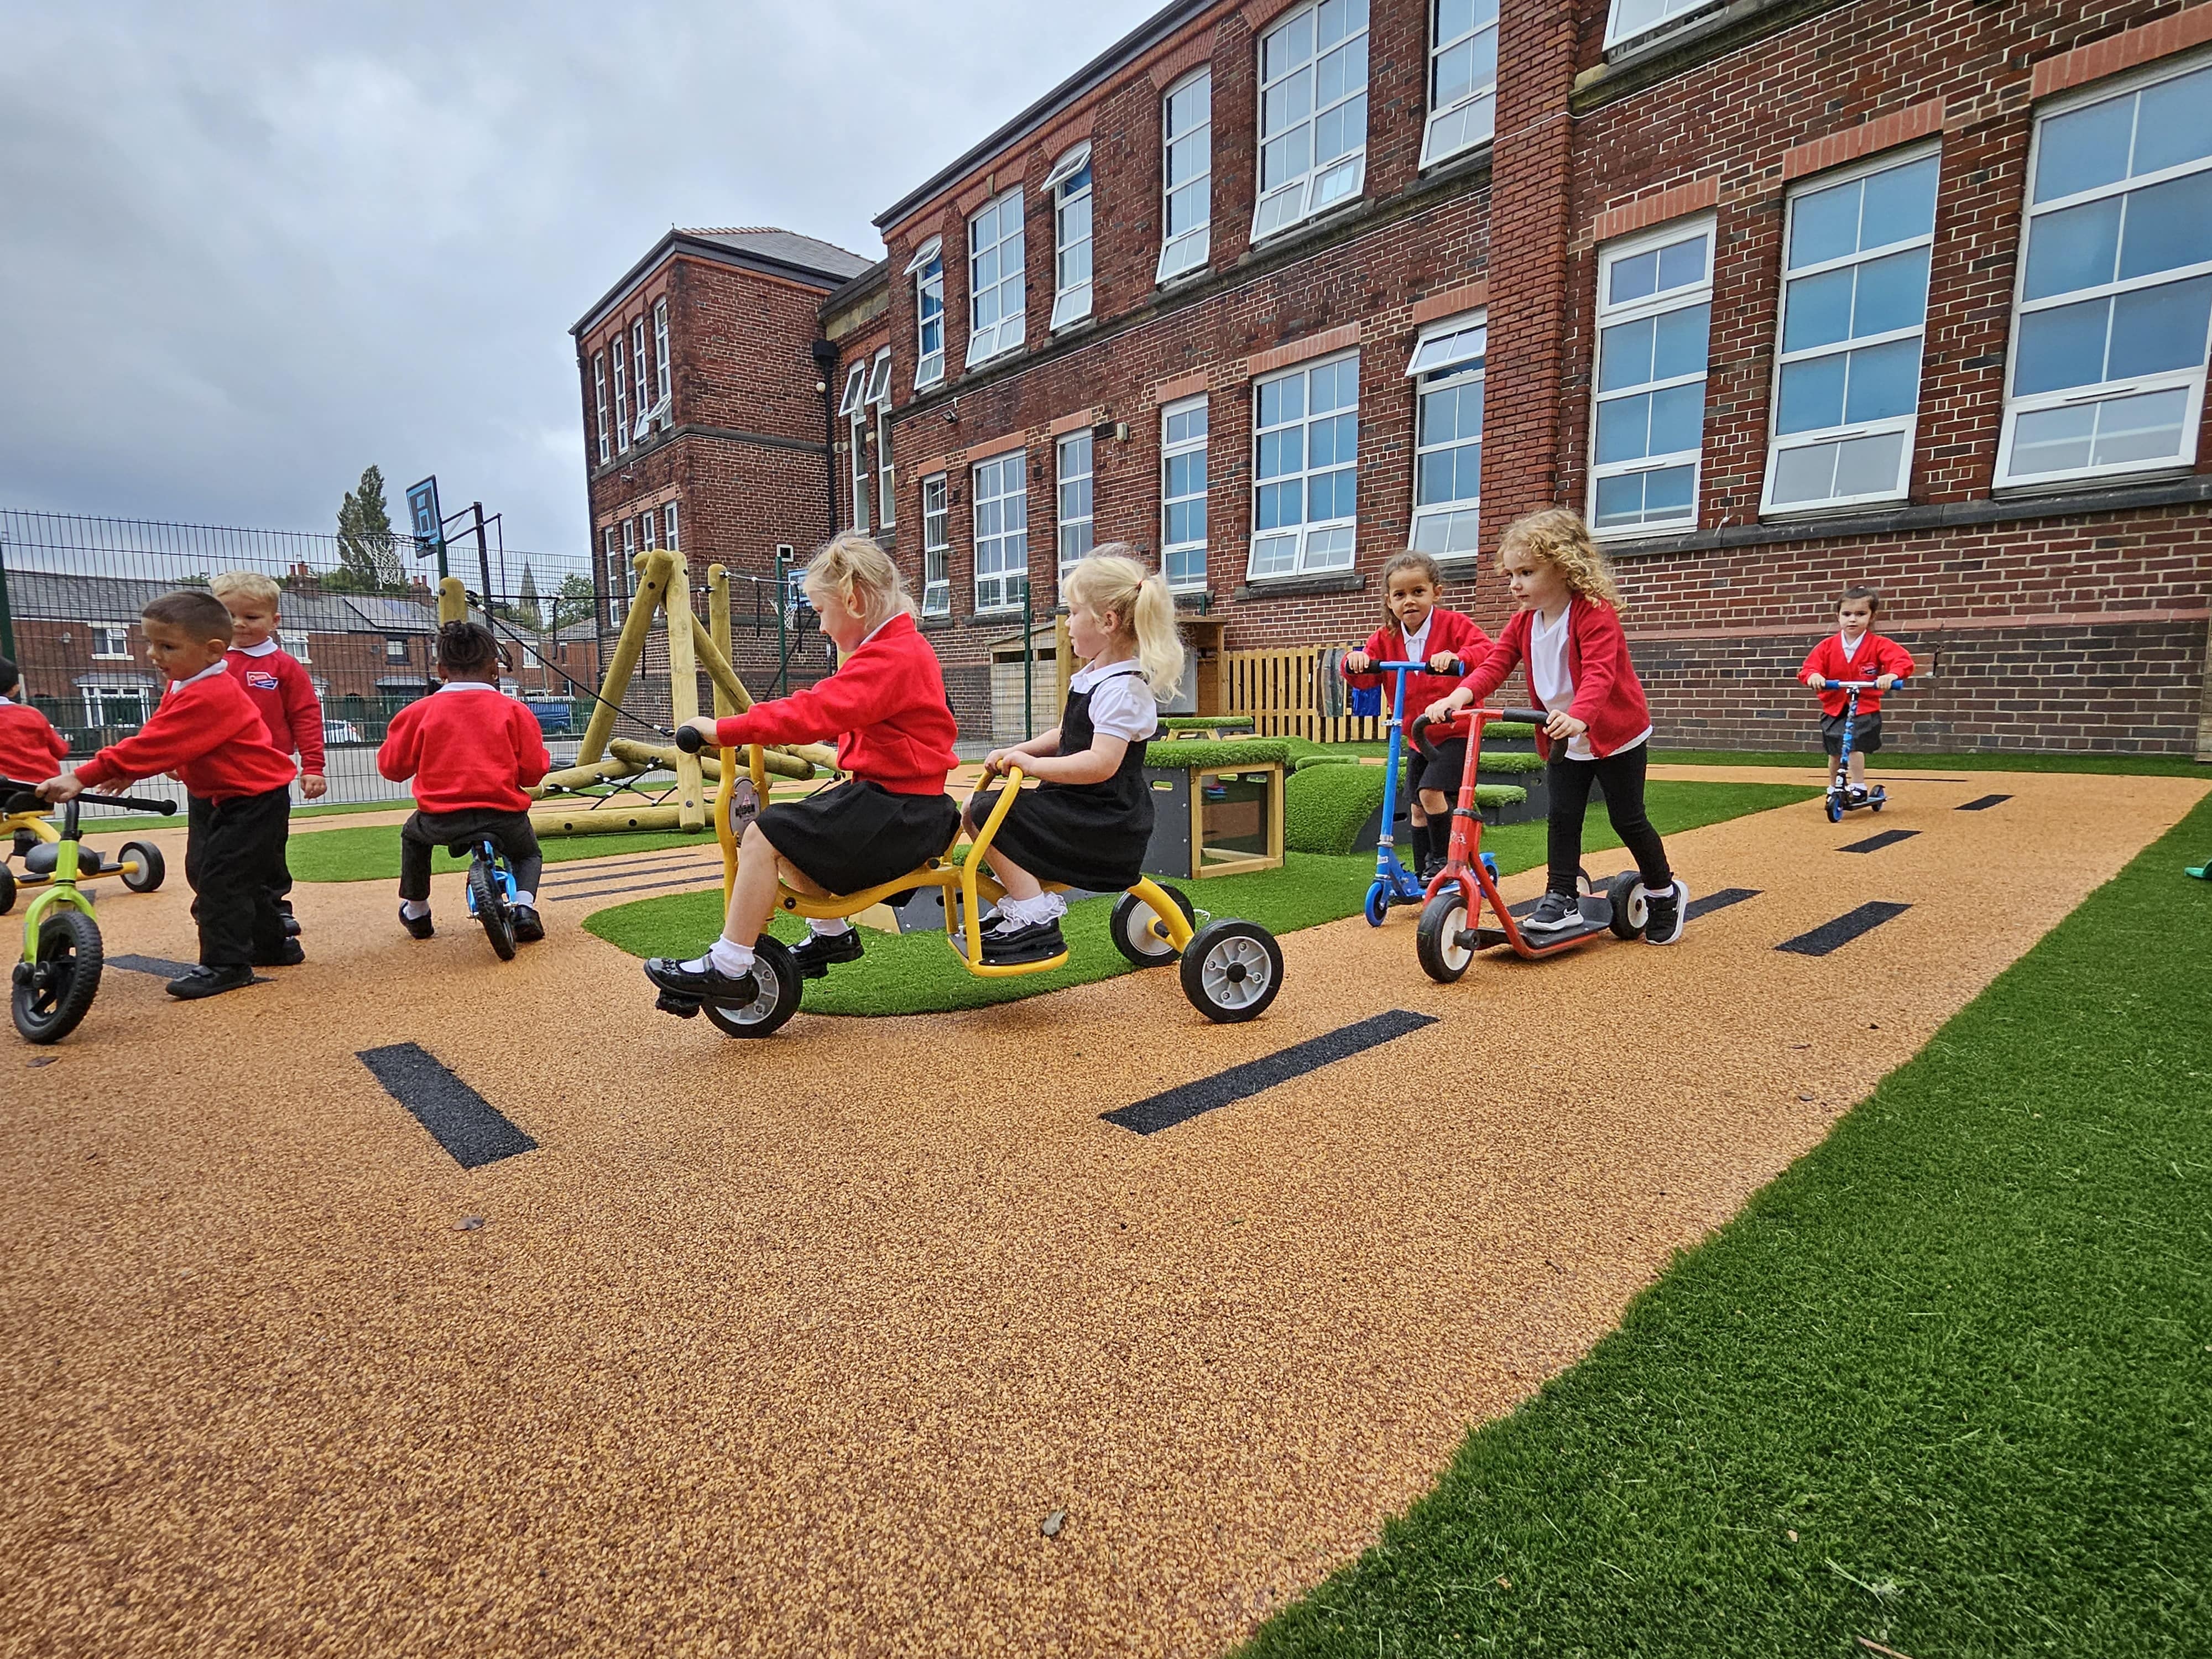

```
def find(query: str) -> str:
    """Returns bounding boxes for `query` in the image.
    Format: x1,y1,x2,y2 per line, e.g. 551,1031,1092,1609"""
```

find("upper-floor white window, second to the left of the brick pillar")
1252,0,1367,241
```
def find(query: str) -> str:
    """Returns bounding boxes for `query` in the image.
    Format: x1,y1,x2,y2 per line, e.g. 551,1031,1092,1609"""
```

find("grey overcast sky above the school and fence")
0,0,1161,562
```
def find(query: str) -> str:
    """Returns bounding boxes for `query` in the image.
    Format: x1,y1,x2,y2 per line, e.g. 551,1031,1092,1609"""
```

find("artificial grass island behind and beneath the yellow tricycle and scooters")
584,783,1820,1015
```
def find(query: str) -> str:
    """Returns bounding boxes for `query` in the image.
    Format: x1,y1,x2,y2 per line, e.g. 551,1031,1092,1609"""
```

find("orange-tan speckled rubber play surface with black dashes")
0,772,2203,1657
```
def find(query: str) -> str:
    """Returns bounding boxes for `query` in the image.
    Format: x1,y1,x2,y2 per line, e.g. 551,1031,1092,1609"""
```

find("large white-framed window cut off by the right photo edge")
1997,58,2212,489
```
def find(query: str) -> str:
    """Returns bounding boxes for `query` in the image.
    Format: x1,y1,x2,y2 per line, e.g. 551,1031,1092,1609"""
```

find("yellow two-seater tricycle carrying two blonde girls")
659,728,1283,1037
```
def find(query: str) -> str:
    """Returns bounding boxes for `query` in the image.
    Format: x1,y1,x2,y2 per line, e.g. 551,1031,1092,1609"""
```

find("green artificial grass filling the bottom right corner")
1245,801,2212,1659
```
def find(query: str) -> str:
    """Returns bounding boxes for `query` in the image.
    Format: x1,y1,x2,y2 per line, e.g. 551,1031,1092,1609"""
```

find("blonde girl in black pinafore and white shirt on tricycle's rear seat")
967,542,1183,964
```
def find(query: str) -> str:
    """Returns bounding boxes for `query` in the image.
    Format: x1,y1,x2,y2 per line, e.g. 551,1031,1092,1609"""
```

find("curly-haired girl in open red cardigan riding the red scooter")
1429,507,1688,945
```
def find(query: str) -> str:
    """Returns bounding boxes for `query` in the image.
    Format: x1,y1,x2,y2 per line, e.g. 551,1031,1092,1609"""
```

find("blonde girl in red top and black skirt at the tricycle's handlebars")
646,531,960,1004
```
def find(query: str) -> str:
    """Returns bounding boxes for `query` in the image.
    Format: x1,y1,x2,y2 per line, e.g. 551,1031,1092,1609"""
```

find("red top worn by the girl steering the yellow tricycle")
714,613,960,794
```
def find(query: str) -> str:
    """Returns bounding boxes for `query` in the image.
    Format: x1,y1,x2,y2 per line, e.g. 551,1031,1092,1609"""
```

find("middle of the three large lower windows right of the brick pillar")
1763,150,1942,513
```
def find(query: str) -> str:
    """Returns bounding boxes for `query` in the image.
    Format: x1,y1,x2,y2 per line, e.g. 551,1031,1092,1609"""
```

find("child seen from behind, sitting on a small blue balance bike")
376,622,553,942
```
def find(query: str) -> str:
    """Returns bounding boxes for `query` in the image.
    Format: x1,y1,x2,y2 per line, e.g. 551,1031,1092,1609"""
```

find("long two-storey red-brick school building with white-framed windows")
580,0,2212,757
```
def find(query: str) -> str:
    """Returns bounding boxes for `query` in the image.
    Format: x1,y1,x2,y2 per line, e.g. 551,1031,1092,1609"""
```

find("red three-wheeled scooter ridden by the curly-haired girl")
1409,708,1644,984
